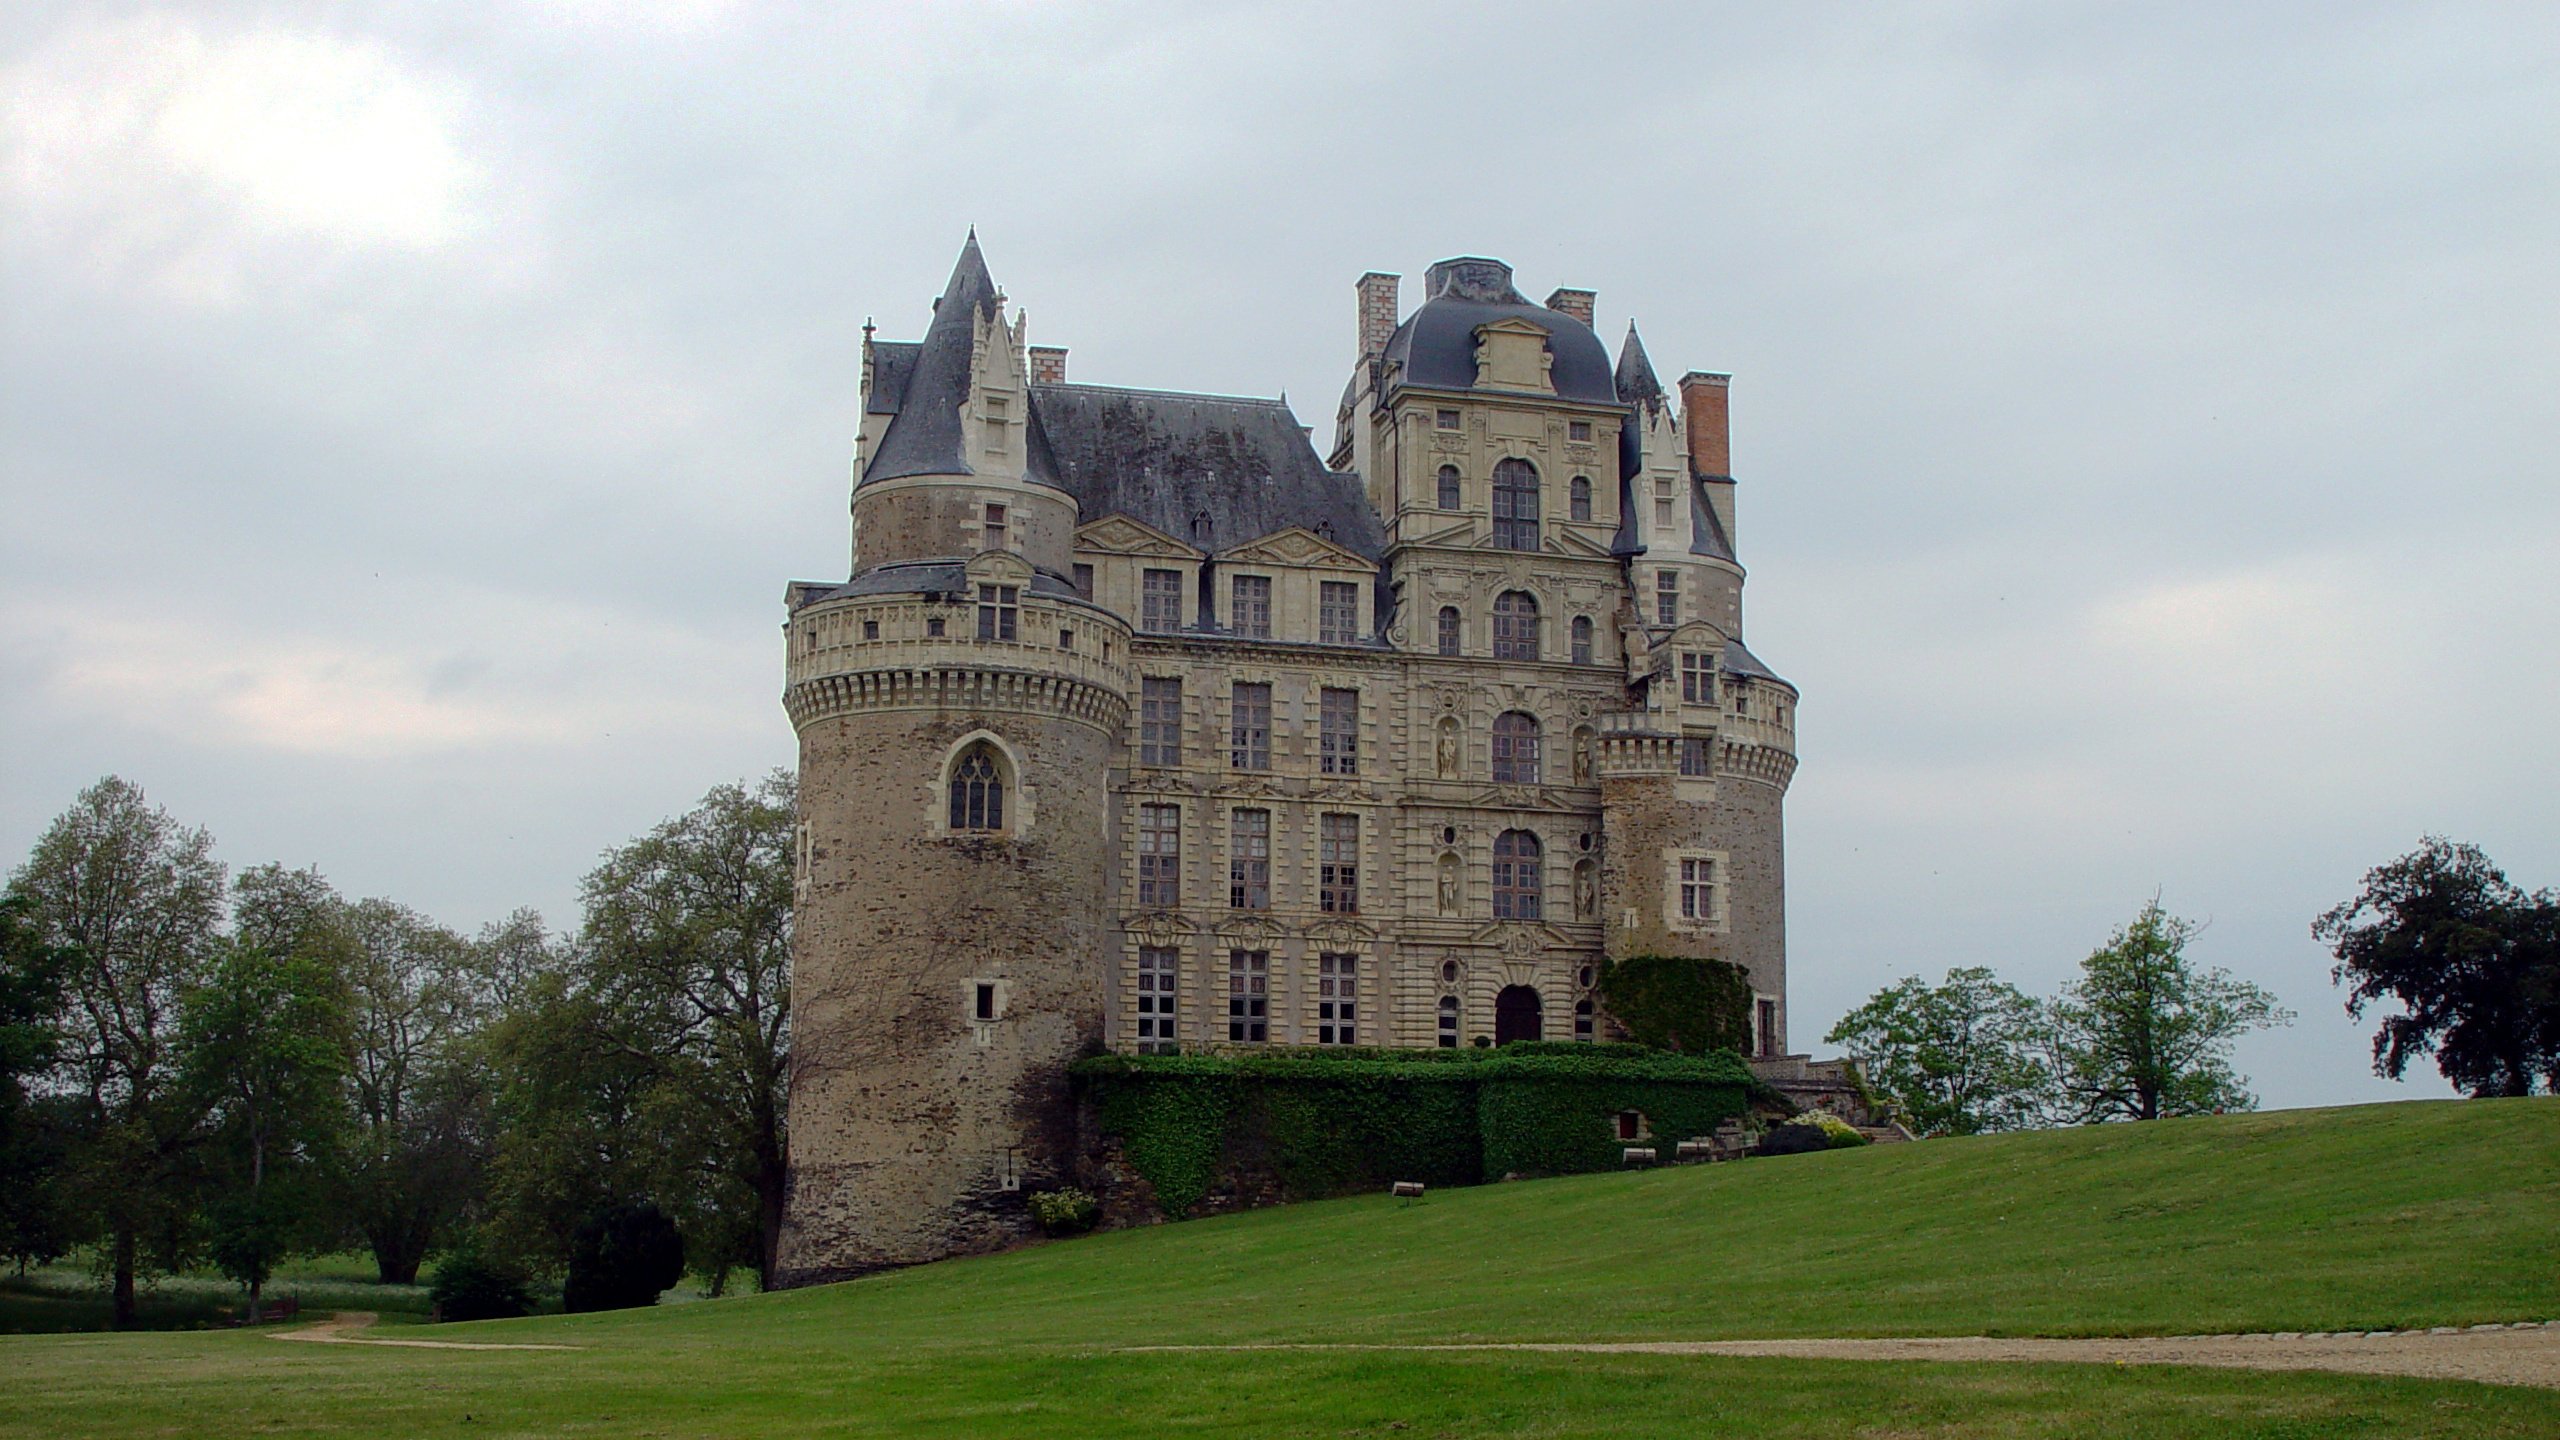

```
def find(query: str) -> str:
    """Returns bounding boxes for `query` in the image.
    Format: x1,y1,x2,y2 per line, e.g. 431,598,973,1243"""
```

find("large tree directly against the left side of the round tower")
581,771,799,1284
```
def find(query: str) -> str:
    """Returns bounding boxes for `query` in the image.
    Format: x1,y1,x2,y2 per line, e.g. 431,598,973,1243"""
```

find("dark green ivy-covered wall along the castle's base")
1073,1040,1756,1217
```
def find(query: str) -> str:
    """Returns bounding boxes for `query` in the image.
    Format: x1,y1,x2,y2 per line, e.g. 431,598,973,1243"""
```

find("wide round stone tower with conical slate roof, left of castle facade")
778,236,1129,1284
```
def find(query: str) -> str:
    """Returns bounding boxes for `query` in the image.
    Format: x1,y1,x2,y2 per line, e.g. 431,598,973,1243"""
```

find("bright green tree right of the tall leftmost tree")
182,912,348,1325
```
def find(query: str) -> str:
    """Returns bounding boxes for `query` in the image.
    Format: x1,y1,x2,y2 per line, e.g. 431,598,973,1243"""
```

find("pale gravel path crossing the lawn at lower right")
1149,1322,2560,1389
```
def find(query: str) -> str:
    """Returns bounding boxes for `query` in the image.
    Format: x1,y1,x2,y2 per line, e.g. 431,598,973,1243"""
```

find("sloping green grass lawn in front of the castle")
0,1099,2560,1435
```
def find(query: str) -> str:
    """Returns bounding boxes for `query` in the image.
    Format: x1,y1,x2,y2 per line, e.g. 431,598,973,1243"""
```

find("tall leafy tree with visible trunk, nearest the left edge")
10,776,225,1327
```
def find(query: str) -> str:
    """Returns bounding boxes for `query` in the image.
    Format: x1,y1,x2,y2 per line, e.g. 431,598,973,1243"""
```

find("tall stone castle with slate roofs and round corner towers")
781,236,1797,1281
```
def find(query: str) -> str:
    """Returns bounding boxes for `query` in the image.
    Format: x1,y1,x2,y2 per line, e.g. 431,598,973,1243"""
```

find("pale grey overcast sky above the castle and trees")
0,0,2560,1104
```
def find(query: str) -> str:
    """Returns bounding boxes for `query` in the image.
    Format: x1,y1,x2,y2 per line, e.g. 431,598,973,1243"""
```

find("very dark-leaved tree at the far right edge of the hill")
2312,835,2560,1097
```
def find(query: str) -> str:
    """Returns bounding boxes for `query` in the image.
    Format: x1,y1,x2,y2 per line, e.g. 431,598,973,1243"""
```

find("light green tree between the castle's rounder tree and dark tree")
2051,899,2294,1122
